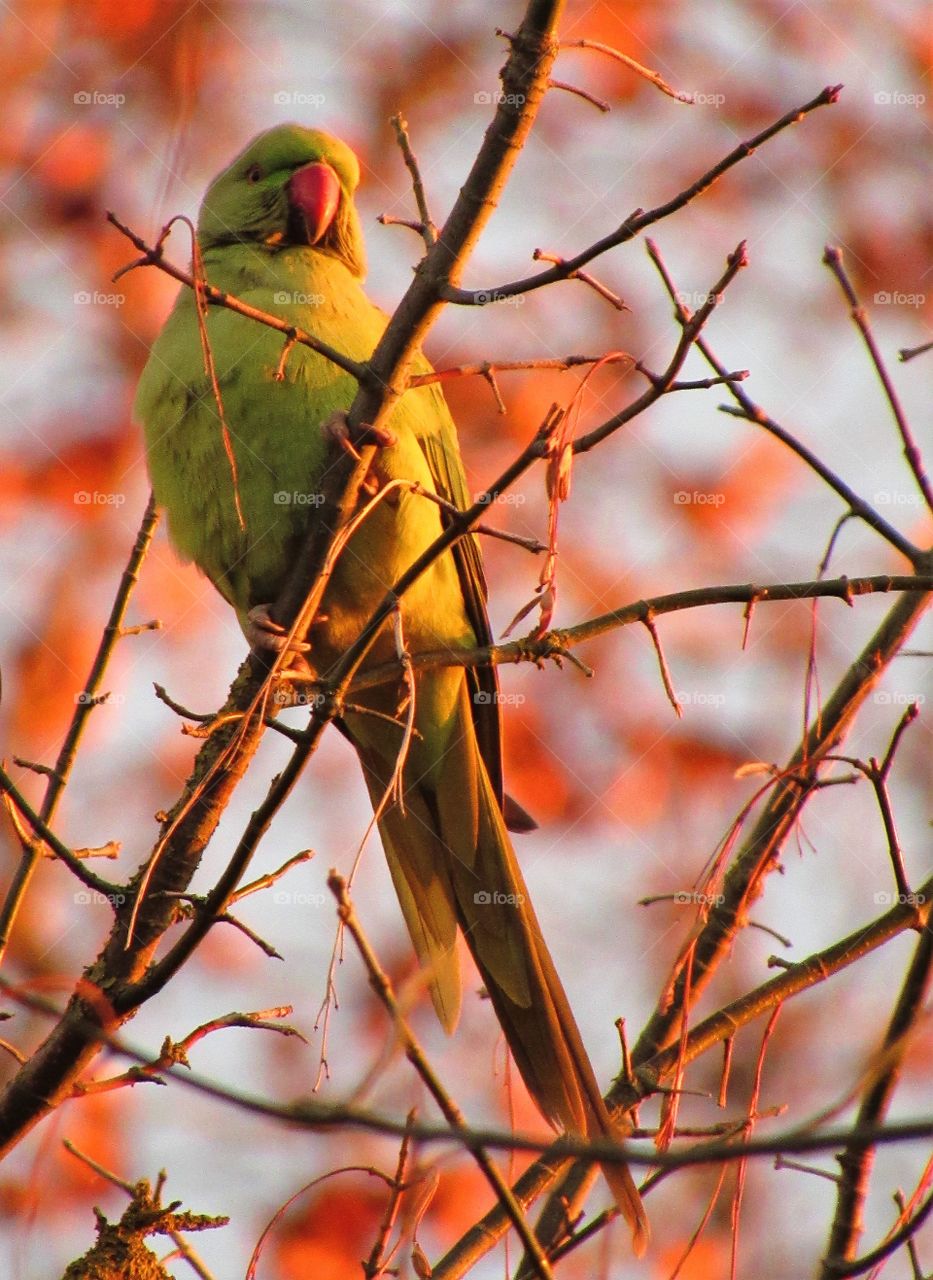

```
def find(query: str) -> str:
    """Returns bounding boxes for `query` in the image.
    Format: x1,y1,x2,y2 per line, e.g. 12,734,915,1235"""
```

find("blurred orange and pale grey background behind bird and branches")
0,0,933,1280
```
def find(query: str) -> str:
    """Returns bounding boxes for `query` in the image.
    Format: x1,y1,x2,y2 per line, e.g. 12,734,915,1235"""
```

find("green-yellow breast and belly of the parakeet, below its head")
136,244,474,666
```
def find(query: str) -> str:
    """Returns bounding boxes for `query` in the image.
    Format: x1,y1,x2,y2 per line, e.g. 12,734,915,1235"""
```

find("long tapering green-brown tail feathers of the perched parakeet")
347,668,649,1254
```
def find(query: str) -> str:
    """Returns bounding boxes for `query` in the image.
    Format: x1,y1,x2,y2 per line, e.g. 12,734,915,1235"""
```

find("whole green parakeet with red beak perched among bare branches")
136,125,648,1252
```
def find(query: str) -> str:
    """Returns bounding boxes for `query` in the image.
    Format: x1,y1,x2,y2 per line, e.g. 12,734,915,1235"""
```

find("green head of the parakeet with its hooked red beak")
197,124,366,276
